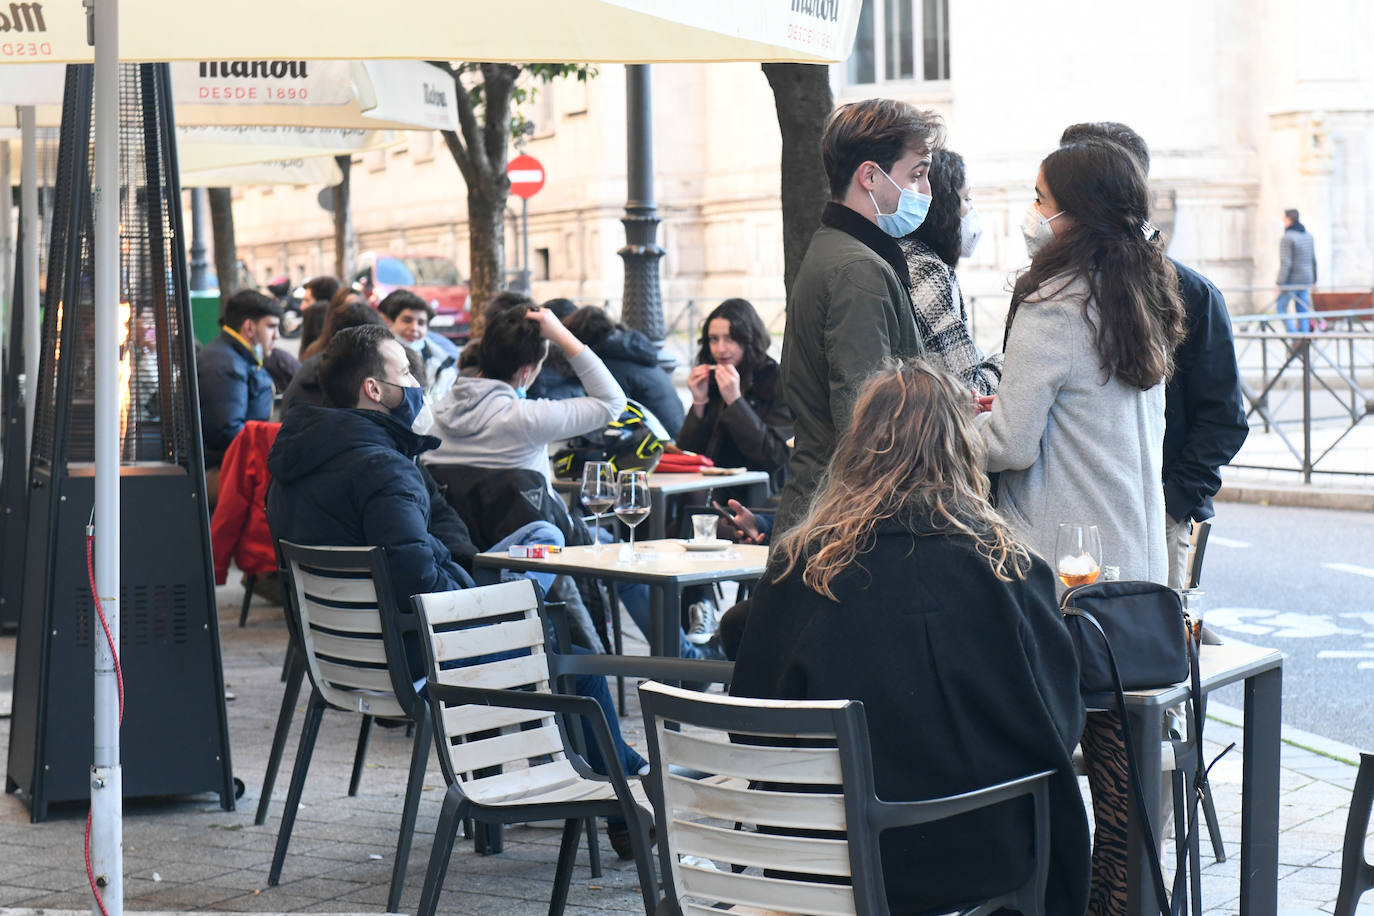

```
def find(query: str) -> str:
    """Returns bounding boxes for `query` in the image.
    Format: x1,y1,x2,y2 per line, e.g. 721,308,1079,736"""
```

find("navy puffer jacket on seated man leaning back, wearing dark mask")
267,404,473,674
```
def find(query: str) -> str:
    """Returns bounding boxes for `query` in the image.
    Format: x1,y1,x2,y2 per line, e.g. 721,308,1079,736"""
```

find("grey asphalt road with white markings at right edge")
1201,503,1374,750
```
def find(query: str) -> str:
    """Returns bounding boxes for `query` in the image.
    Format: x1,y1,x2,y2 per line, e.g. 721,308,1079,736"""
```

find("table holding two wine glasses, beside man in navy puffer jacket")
474,538,768,658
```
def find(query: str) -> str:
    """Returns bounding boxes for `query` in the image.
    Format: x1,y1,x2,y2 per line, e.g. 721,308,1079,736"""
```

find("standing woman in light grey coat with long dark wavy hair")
977,140,1184,916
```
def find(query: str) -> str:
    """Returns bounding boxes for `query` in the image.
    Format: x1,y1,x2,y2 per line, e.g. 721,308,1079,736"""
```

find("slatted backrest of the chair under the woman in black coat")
639,683,882,916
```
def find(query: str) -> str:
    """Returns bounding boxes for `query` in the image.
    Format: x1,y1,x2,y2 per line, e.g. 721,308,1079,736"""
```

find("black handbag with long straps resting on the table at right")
1059,581,1203,916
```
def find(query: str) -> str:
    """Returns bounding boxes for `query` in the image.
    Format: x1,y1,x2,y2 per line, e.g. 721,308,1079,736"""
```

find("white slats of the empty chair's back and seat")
415,580,583,805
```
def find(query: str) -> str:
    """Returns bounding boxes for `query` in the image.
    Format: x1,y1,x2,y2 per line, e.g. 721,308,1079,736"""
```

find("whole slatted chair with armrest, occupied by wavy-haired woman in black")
639,683,1051,916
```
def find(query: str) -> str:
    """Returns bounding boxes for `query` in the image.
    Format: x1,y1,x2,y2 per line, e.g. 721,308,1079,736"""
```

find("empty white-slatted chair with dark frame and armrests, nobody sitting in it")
414,580,657,916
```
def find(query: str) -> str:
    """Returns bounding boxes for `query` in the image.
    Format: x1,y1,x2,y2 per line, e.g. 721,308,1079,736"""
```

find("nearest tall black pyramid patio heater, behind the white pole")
5,65,234,821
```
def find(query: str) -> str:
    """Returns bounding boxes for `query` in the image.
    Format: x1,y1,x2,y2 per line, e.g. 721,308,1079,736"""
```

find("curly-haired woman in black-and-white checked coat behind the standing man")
897,150,1002,394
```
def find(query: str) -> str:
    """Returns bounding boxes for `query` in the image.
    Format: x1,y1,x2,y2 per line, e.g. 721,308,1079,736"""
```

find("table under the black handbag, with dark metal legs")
1084,644,1283,916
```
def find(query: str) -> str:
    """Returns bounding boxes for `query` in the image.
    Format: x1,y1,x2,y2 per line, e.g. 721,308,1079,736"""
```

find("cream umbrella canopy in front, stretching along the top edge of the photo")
8,0,860,63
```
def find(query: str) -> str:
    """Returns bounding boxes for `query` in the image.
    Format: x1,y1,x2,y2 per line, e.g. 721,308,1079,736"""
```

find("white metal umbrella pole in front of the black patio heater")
90,0,124,916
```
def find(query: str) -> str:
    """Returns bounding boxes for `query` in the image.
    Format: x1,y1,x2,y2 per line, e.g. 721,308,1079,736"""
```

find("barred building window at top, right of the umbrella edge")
845,0,949,85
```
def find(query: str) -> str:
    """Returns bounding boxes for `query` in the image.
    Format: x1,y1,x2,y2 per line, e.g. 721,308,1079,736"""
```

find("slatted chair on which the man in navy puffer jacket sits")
259,541,431,912
